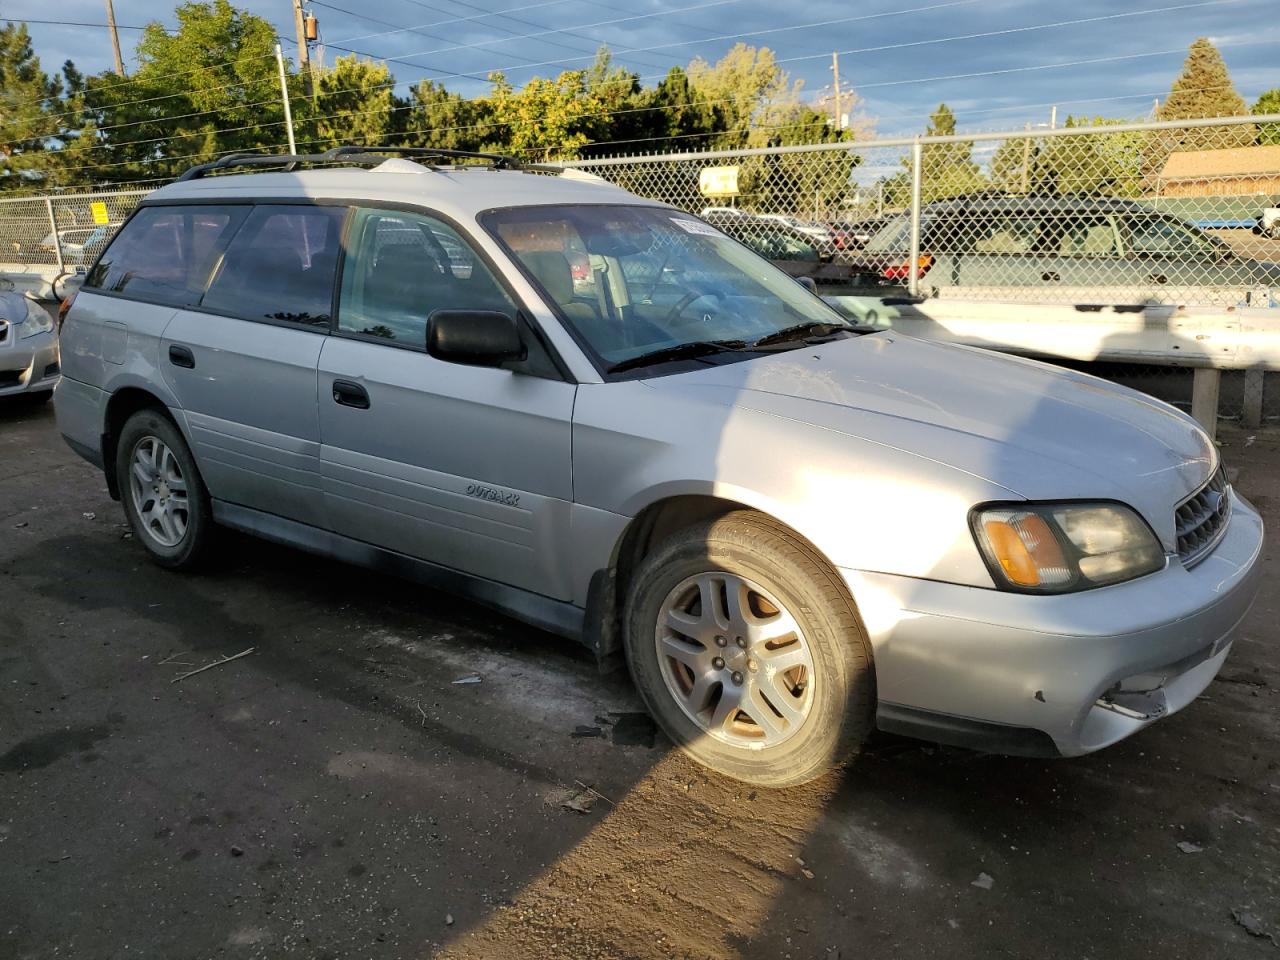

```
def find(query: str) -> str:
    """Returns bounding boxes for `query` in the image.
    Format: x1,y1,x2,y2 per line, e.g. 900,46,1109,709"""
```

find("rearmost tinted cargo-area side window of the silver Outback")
84,206,248,306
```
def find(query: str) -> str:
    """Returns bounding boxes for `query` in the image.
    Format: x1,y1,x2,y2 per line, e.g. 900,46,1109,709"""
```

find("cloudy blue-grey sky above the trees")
10,0,1280,136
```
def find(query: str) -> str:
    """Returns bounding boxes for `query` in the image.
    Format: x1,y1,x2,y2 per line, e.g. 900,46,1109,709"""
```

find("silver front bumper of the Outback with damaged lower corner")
841,490,1263,756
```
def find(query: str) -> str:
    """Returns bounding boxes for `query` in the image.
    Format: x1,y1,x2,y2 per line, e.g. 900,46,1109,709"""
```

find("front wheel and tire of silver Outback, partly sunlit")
625,511,876,787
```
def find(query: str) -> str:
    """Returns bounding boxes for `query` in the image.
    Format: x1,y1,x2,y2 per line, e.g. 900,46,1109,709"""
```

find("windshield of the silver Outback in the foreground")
483,205,851,367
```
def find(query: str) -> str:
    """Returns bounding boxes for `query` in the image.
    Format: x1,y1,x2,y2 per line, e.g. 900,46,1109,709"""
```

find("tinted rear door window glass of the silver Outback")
201,204,347,328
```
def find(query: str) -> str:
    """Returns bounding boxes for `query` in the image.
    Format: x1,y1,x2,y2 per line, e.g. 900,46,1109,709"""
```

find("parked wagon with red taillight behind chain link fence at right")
858,196,1280,303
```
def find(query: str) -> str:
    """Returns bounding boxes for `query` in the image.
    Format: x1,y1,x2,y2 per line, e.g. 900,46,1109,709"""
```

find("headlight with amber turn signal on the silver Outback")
970,503,1165,594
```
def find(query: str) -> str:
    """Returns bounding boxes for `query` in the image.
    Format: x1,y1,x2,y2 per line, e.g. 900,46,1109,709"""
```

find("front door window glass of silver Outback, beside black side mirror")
338,210,516,347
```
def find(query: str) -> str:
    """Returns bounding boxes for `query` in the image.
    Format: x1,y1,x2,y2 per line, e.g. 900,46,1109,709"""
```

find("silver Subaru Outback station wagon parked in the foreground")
56,147,1262,786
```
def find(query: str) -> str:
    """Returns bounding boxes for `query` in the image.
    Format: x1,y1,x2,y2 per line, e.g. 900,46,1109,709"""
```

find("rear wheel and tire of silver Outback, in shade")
115,410,214,570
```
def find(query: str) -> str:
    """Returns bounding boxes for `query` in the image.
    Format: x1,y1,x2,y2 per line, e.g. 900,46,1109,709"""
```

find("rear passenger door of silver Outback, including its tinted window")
160,204,347,526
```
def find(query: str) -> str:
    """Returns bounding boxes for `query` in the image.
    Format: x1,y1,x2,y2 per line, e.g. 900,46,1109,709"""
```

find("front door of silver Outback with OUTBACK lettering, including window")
319,209,576,599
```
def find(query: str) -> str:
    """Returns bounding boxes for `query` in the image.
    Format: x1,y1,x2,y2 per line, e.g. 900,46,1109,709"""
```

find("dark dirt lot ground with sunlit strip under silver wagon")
0,394,1280,960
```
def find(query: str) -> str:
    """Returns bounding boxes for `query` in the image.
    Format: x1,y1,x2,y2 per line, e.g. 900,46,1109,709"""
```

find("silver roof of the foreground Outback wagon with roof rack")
143,157,662,220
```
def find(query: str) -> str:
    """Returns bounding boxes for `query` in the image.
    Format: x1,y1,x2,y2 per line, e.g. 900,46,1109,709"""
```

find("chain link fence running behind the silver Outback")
0,115,1280,420
